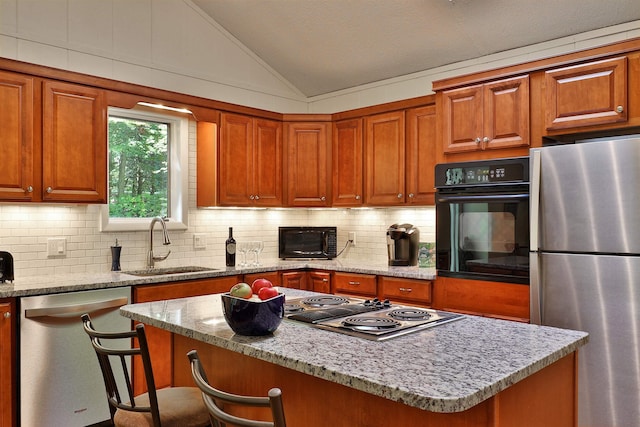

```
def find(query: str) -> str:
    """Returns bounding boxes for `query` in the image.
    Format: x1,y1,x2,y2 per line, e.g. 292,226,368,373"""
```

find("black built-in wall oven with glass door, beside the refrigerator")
435,157,529,284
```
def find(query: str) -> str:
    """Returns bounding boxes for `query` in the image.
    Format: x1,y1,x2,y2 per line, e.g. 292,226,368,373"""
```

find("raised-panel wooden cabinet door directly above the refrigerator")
545,57,628,130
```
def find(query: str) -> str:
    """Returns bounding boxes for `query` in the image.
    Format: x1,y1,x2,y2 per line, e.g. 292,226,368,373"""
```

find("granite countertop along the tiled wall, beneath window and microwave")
0,260,436,298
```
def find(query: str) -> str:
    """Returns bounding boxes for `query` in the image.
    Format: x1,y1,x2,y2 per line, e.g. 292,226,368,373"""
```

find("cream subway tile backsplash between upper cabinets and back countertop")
0,118,435,279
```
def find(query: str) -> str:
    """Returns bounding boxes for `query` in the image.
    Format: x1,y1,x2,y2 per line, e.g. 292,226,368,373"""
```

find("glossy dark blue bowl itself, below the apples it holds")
222,293,284,336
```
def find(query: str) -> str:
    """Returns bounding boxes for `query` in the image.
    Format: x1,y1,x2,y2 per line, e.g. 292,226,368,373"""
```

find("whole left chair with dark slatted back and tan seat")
82,314,211,427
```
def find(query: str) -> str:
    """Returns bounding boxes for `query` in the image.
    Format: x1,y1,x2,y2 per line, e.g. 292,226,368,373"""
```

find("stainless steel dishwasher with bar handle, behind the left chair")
20,287,131,427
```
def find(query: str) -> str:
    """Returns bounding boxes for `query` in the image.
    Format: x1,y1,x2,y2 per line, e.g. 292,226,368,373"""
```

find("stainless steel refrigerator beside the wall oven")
530,135,640,427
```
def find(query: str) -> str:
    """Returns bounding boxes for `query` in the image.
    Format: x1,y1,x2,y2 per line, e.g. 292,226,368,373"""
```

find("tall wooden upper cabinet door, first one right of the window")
218,113,254,206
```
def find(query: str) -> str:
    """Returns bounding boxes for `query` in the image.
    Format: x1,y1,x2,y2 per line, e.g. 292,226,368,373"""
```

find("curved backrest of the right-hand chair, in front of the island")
187,350,286,427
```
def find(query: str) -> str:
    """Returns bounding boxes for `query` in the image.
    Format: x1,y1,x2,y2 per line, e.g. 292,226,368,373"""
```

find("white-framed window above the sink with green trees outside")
101,107,188,231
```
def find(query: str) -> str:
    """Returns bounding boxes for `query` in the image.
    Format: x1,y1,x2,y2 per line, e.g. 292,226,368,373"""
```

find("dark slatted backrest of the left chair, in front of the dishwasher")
82,314,161,427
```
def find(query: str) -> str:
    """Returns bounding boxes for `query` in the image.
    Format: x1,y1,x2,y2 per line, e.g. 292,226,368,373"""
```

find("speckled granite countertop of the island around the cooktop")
121,288,588,412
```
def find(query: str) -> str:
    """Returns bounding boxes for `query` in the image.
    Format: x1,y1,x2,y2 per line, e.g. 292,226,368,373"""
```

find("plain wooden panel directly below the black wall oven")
433,277,529,322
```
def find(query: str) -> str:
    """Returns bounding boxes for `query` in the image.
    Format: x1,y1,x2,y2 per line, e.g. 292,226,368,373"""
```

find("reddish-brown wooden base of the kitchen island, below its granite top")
173,335,577,427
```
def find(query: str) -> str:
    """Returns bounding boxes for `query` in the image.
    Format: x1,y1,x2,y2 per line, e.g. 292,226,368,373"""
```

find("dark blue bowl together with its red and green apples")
222,279,284,336
